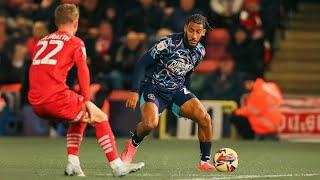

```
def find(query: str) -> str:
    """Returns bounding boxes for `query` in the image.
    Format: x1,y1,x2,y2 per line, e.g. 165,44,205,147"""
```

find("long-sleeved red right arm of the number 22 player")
74,43,90,102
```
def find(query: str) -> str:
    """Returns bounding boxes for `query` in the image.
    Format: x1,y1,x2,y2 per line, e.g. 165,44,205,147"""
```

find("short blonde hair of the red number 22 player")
54,4,79,26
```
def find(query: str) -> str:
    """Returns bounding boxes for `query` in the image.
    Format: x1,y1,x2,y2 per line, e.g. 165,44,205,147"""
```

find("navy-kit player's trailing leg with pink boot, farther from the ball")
121,92,165,163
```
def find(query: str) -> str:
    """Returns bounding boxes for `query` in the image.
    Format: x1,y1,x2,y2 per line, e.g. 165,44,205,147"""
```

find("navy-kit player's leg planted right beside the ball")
174,90,215,170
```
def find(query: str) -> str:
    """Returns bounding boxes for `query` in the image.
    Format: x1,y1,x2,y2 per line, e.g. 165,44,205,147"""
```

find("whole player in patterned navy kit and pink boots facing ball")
121,14,215,171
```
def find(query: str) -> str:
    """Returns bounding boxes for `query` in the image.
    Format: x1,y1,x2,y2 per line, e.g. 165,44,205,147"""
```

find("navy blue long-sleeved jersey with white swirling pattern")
132,33,205,92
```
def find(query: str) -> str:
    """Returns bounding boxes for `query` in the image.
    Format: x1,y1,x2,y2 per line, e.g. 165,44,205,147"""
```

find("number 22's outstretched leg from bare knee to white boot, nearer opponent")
82,102,144,176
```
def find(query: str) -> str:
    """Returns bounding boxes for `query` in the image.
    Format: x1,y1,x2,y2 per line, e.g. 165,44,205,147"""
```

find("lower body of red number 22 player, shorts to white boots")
34,91,144,176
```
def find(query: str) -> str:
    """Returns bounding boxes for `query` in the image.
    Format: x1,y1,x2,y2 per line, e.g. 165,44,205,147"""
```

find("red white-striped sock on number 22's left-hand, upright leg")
67,121,87,156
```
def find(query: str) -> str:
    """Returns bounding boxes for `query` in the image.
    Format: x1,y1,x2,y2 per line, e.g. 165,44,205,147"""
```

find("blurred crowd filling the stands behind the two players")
0,0,298,136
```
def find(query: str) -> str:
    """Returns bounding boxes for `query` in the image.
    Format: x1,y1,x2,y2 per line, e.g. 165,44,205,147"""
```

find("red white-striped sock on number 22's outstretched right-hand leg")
94,121,118,162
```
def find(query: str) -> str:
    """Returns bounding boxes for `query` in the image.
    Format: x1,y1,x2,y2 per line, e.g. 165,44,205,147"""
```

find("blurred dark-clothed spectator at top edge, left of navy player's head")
124,0,163,35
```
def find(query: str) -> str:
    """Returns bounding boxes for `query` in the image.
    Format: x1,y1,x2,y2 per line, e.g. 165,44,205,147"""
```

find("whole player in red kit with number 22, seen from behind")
28,4,144,176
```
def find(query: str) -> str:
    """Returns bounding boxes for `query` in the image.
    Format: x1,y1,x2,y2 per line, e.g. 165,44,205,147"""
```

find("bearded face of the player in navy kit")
184,22,206,47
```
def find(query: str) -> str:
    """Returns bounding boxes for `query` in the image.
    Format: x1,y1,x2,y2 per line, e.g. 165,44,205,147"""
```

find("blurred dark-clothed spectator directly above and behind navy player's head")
164,0,202,33
